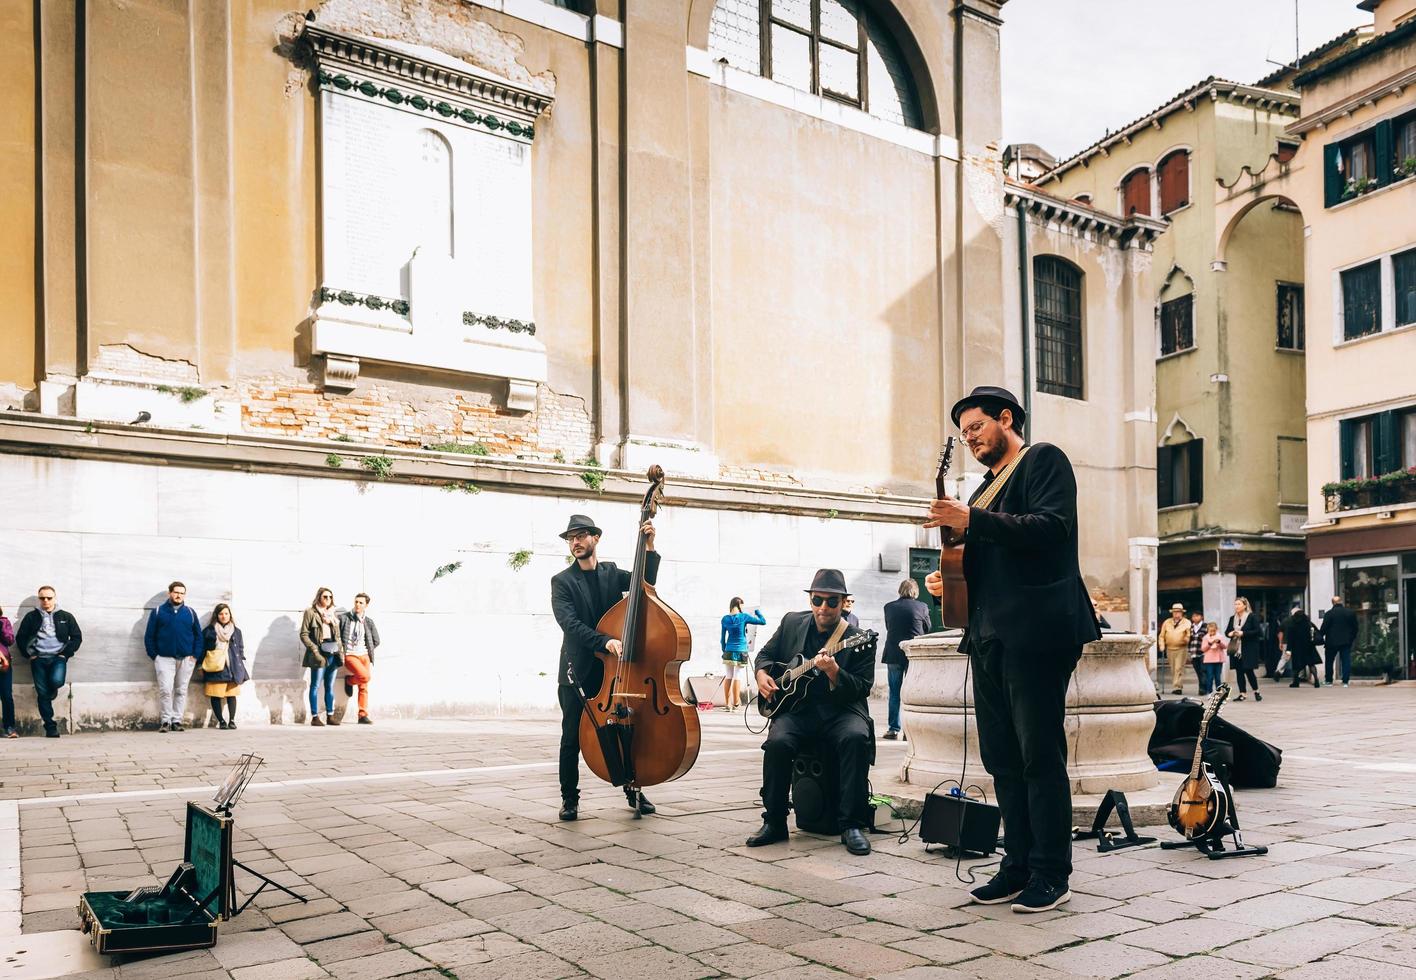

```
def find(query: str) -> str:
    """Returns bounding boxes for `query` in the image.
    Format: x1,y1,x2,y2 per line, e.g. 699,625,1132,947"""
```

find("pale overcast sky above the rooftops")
1003,0,1372,160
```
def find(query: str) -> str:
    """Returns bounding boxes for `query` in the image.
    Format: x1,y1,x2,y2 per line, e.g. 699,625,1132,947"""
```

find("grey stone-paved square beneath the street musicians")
0,685,1416,980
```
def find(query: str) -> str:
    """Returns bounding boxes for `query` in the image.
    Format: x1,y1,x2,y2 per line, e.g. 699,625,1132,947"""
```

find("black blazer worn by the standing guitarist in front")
963,442,1102,651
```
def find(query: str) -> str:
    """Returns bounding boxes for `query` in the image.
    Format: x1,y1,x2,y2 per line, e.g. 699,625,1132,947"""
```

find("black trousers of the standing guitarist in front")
970,642,1080,884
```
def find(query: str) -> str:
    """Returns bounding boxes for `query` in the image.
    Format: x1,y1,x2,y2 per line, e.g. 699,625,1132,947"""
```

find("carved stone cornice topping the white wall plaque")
300,24,554,139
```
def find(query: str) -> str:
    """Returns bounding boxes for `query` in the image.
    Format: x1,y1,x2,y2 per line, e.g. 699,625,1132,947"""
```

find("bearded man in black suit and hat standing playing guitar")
925,385,1100,912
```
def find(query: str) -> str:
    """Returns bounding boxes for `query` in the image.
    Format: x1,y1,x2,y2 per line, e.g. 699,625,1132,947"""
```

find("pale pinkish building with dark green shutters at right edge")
1280,0,1416,678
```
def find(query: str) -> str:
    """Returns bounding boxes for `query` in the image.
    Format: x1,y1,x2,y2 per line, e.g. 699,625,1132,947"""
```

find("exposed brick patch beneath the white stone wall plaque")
241,381,592,462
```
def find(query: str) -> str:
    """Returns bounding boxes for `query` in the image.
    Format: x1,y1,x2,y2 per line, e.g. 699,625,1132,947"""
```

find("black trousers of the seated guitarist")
762,704,871,830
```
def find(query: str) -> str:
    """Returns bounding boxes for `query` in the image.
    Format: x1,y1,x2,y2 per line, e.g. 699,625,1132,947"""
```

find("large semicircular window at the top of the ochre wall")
708,0,923,129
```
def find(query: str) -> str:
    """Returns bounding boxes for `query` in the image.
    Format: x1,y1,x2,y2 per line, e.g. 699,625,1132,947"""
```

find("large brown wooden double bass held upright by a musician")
581,466,702,819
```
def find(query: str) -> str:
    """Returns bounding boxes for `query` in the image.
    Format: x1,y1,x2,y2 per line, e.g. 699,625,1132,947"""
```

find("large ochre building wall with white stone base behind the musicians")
0,0,1154,725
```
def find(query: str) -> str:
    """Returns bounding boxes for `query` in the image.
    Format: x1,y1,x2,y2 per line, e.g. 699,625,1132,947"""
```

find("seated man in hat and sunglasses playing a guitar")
748,568,875,854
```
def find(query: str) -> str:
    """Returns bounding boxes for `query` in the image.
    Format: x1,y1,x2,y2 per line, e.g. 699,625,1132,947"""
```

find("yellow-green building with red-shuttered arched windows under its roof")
1037,78,1307,628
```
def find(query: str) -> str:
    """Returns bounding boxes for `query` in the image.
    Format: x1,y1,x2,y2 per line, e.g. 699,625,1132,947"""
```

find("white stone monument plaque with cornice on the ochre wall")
304,25,551,397
